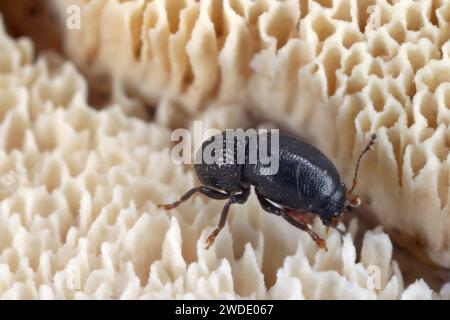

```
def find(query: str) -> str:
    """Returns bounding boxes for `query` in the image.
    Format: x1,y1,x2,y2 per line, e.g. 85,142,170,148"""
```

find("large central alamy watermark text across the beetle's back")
171,121,279,175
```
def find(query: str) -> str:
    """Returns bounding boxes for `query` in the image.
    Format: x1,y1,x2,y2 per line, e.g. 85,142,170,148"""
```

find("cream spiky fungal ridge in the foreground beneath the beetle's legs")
0,14,448,299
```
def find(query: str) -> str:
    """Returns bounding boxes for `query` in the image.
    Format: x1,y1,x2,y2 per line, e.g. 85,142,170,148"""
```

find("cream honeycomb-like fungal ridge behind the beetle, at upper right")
48,0,450,267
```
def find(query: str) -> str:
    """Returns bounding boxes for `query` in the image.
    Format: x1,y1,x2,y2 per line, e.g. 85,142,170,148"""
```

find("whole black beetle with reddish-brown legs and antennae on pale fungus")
158,129,376,250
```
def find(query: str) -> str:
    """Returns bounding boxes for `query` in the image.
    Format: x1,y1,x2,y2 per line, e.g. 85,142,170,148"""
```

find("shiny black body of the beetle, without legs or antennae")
195,133,347,225
